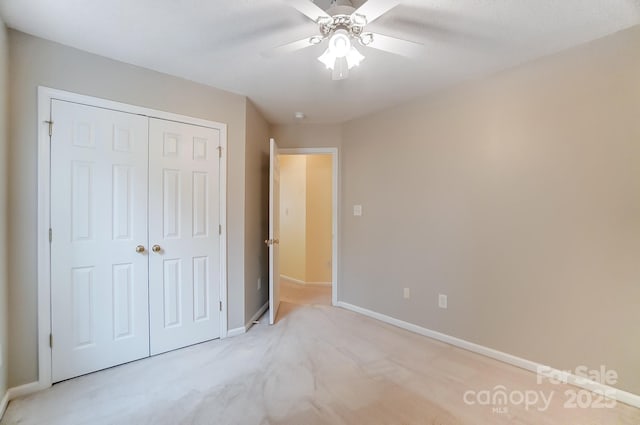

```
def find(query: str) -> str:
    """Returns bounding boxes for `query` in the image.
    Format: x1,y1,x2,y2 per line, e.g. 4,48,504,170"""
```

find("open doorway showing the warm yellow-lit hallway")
279,149,337,311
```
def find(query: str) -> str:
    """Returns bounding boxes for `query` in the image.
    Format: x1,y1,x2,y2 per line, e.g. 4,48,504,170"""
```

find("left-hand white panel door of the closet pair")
51,100,149,382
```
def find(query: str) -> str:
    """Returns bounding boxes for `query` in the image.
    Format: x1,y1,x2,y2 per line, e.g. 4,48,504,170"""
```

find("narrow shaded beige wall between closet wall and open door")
244,101,269,324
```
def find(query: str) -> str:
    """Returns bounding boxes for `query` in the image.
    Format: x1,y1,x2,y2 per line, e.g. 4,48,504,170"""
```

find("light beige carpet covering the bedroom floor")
1,292,640,425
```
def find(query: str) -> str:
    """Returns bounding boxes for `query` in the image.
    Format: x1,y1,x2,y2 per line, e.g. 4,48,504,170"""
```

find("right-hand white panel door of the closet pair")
149,118,221,355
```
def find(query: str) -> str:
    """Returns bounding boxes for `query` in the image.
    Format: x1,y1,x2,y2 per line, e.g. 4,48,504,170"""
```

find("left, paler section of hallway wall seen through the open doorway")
280,155,307,282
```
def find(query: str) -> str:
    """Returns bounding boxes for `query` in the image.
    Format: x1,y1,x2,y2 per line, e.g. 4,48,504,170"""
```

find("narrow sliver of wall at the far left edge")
0,19,9,399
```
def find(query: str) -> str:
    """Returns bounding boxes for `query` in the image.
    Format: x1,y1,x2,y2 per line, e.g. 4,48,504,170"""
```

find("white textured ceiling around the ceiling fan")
0,0,640,123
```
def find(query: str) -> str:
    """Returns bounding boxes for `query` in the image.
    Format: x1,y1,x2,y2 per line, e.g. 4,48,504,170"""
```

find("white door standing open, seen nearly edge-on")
265,139,280,325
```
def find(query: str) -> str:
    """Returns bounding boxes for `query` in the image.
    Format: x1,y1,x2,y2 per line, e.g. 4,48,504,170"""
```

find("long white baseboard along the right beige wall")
337,301,640,408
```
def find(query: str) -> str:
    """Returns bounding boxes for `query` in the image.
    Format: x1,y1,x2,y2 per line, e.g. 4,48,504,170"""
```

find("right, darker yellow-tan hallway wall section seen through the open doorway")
305,155,333,283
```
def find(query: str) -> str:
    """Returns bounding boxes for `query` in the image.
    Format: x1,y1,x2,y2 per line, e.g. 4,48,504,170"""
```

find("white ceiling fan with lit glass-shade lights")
263,0,423,80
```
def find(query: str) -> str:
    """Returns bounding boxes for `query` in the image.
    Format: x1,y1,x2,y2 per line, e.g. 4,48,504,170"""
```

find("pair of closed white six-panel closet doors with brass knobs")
51,100,221,382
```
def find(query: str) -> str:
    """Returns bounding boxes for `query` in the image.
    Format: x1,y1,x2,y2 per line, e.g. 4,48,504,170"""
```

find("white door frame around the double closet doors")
34,86,228,390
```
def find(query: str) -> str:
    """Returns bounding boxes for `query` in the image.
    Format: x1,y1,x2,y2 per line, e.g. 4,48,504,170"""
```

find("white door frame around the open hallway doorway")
279,148,340,306
